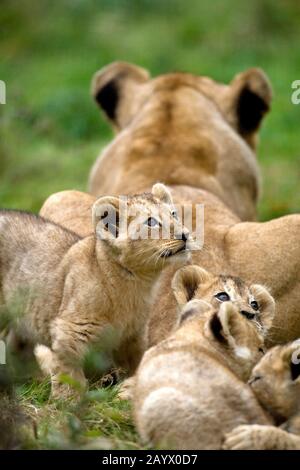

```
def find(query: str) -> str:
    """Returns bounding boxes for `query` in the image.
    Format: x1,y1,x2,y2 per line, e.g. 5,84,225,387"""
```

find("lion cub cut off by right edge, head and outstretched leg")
223,340,300,450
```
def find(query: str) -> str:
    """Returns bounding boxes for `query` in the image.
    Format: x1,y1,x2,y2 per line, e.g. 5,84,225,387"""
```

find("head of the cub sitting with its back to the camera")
179,299,264,381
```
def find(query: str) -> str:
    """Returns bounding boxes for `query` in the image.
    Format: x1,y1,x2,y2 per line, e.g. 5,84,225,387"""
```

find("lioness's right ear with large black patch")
229,68,272,145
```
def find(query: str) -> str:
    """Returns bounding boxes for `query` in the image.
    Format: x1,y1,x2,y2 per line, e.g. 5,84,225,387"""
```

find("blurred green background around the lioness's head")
0,0,300,220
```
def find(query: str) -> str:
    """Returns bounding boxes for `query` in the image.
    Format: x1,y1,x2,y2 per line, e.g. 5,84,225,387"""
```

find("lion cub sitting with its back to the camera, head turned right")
133,300,269,449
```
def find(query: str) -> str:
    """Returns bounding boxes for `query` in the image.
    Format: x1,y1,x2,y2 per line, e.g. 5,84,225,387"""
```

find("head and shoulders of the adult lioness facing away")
90,62,271,220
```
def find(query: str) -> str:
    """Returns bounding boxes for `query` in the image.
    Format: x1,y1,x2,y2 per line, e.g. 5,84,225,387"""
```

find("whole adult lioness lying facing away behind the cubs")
41,63,300,344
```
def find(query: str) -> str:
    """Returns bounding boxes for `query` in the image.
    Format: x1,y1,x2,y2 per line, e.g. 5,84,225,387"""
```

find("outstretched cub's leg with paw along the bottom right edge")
223,424,300,450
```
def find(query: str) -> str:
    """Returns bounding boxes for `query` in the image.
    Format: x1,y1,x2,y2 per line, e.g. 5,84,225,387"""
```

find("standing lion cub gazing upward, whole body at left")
0,184,192,396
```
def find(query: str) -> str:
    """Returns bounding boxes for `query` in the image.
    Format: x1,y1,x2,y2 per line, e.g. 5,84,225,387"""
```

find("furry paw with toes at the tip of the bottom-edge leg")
223,424,270,450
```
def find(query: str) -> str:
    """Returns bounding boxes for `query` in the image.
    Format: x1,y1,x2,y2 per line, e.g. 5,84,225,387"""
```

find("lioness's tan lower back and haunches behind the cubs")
41,187,300,345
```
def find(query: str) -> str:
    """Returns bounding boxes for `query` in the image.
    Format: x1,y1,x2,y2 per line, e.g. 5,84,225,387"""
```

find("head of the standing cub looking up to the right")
92,183,194,273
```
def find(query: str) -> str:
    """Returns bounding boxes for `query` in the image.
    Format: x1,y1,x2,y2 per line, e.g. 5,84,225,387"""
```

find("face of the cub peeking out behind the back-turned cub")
172,265,275,333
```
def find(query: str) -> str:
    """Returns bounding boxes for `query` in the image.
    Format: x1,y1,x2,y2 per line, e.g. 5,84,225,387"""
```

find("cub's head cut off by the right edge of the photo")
249,340,300,424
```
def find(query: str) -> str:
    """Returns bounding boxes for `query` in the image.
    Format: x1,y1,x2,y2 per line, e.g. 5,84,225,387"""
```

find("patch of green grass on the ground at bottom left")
17,380,142,449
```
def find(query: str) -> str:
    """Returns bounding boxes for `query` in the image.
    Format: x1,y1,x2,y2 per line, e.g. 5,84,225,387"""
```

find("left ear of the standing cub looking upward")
92,196,120,239
